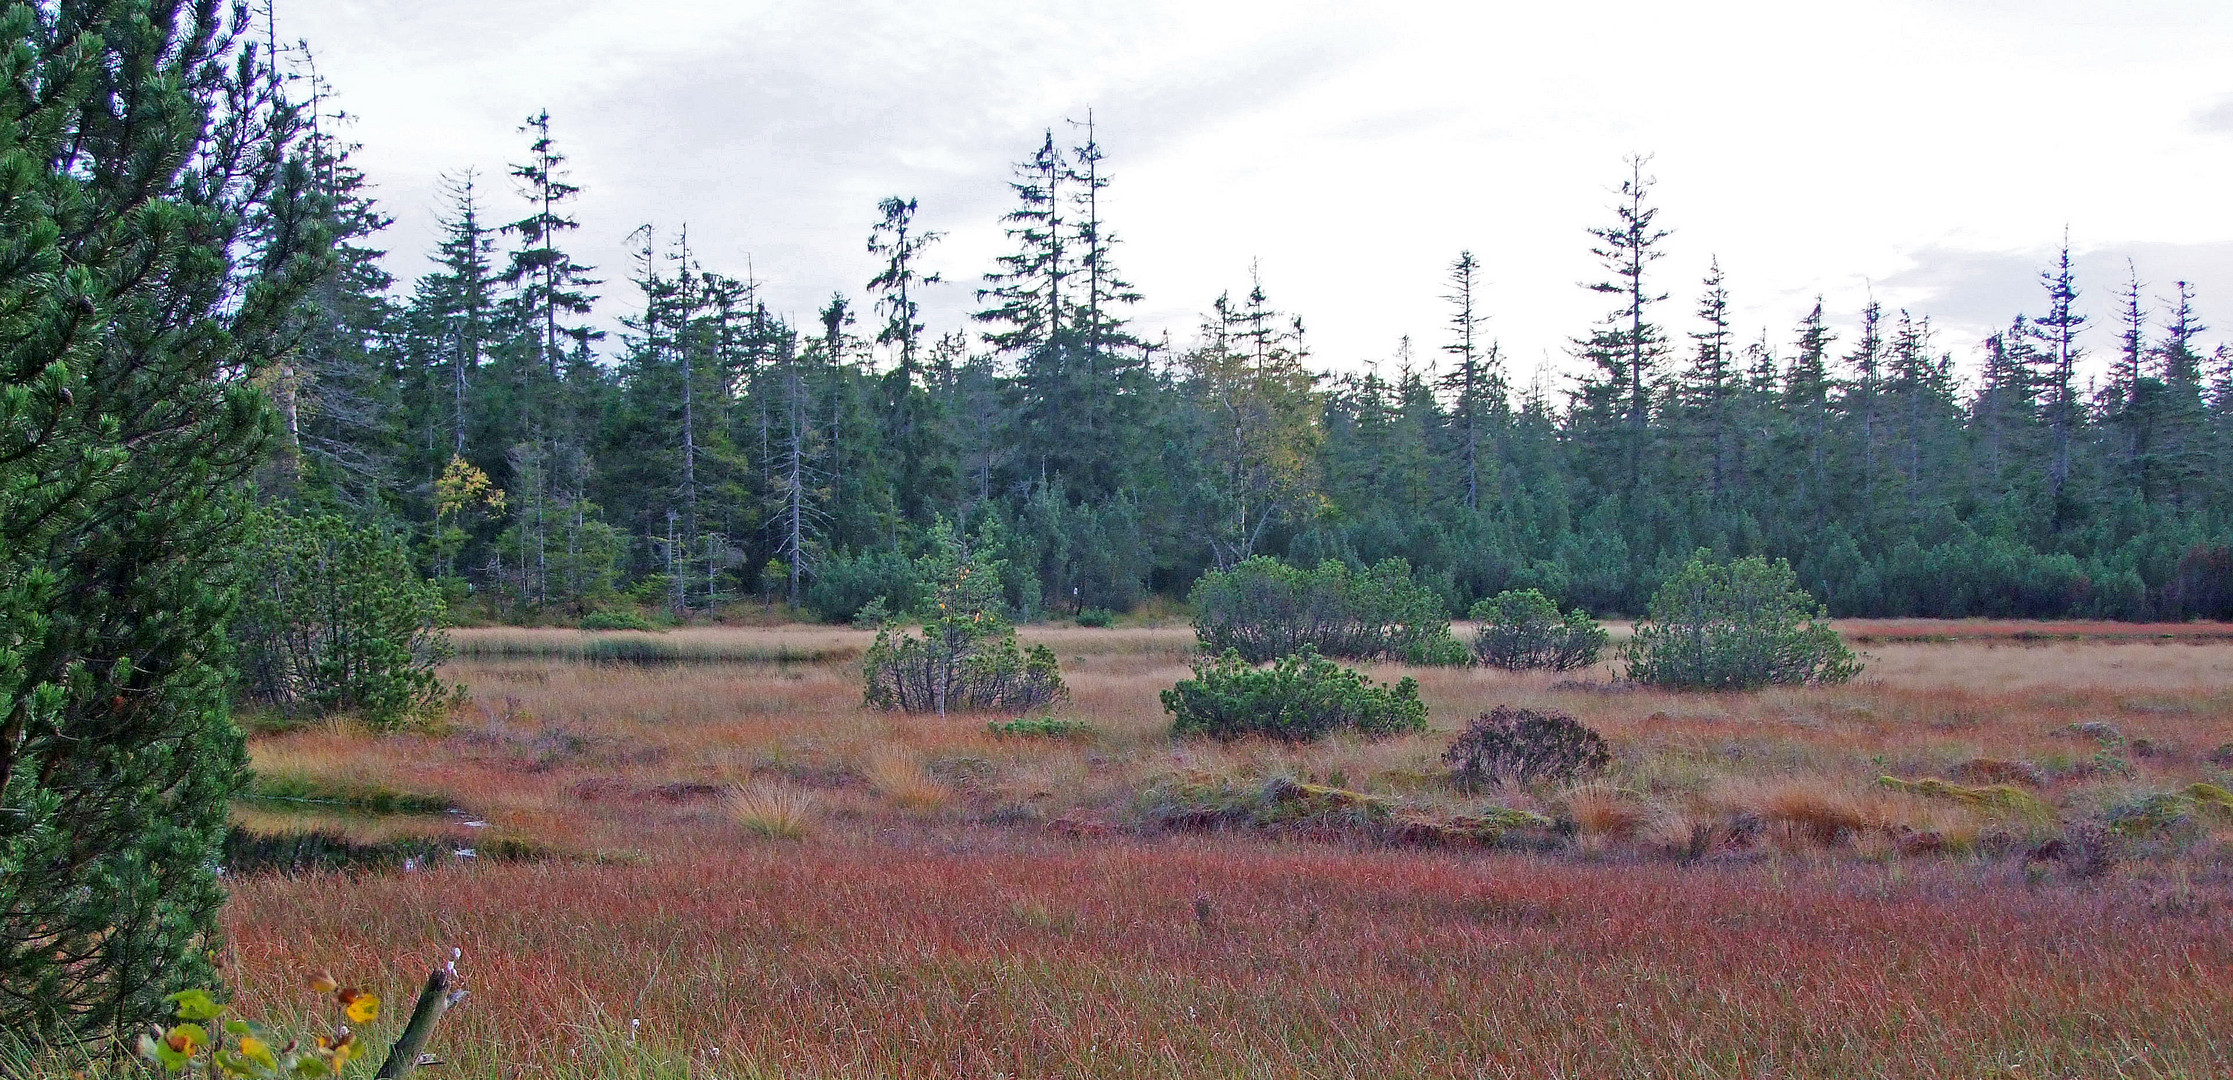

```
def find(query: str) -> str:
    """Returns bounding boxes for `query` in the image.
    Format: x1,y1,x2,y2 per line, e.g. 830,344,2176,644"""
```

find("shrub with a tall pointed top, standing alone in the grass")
862,524,1067,716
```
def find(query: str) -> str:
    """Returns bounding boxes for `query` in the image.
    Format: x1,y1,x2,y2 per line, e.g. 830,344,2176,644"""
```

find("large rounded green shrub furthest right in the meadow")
1623,553,1860,690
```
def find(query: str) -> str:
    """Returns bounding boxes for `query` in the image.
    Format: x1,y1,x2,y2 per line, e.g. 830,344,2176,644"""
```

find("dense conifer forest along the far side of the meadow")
279,105,2233,620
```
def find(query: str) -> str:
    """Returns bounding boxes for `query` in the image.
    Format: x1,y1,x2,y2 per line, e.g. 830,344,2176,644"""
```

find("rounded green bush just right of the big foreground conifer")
232,511,460,730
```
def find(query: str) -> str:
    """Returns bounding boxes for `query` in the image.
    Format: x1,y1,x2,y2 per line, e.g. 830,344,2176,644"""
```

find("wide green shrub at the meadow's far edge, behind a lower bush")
1188,556,1467,665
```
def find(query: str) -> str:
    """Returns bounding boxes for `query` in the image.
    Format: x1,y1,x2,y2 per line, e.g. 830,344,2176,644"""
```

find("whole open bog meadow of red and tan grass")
228,620,2233,1078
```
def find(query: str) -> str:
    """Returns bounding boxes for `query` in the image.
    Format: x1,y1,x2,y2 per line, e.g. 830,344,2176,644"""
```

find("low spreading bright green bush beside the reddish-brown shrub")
1163,645,1427,741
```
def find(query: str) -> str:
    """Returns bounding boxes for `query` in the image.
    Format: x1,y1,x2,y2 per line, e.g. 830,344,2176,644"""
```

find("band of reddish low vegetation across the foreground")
232,832,2233,1078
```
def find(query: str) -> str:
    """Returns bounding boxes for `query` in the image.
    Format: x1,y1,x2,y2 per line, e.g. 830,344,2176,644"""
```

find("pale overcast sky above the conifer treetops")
279,0,2233,393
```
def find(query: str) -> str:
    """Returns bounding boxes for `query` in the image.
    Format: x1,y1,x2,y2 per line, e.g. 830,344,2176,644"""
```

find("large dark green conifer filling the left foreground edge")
0,0,330,1038
